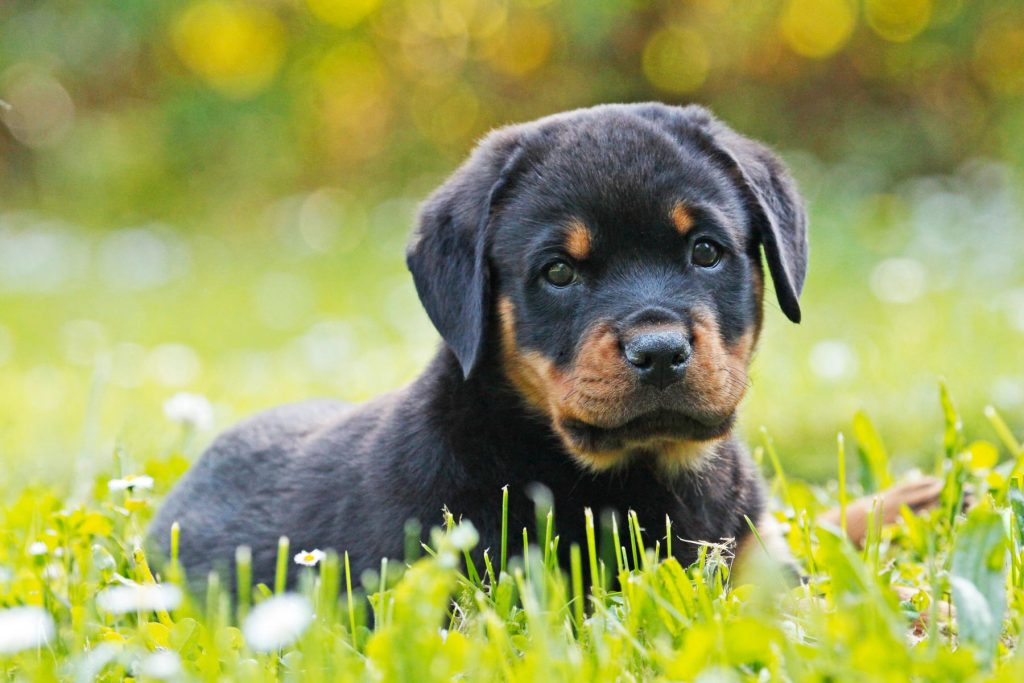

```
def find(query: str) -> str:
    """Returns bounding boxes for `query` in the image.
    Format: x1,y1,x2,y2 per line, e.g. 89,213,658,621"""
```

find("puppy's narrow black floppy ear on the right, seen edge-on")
642,105,808,323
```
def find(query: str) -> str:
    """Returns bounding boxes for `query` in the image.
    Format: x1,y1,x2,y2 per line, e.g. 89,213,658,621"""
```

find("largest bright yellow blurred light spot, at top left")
171,0,285,97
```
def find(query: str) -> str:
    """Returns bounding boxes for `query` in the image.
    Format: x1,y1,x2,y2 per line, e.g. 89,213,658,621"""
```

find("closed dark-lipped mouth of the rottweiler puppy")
560,409,736,453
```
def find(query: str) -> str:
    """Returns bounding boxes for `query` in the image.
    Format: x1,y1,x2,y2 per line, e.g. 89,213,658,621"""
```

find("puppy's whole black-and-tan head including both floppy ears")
408,104,807,469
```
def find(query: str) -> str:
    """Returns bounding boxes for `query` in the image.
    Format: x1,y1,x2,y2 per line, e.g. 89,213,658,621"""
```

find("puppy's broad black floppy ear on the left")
406,129,521,377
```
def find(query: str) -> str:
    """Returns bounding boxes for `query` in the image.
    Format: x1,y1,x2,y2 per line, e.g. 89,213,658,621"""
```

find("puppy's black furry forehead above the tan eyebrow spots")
510,116,742,239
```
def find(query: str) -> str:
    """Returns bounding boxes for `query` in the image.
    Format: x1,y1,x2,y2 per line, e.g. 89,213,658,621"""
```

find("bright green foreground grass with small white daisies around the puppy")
0,387,1024,681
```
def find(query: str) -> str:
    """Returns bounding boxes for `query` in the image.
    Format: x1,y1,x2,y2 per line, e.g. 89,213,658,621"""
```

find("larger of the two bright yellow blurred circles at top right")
779,0,857,59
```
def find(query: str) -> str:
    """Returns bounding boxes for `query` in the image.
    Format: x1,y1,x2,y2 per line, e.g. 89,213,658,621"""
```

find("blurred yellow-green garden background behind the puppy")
0,0,1024,485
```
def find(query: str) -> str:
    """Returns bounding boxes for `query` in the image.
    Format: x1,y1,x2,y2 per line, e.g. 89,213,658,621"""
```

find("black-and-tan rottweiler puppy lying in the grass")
150,103,808,583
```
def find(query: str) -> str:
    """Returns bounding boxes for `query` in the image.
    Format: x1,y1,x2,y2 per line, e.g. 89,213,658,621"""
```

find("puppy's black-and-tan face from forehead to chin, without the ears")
489,125,762,469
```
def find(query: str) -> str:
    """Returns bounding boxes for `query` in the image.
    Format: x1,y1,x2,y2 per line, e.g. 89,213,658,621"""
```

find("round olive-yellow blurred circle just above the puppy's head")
642,27,711,93
